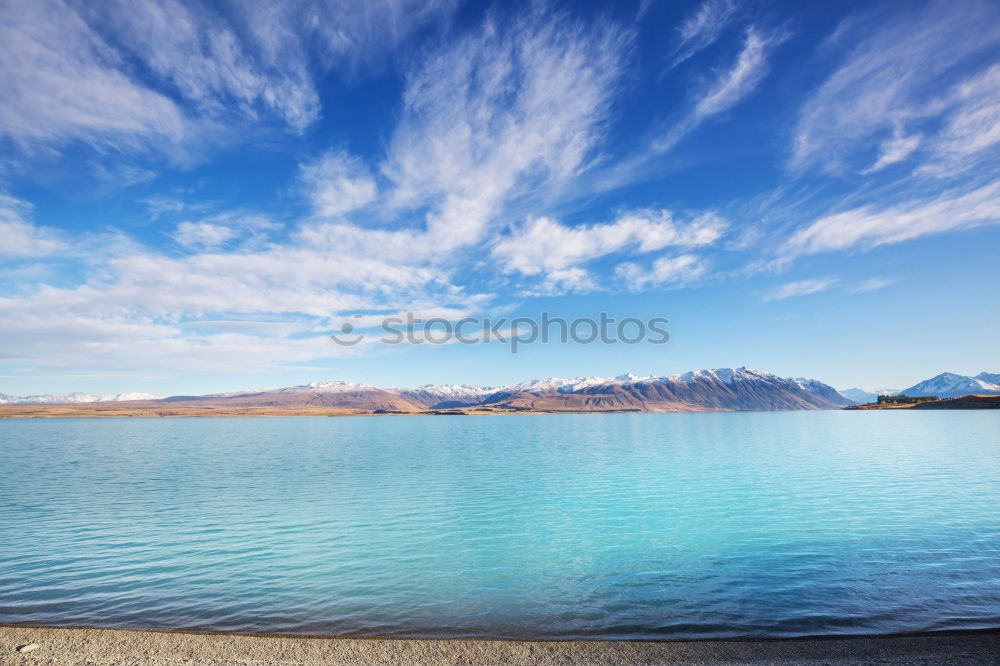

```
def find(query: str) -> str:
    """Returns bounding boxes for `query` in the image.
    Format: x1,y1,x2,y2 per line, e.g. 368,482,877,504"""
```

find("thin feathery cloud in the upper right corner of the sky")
791,0,1000,172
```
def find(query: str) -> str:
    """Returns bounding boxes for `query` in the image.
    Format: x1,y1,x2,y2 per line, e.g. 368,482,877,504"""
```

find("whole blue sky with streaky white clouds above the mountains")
0,0,1000,395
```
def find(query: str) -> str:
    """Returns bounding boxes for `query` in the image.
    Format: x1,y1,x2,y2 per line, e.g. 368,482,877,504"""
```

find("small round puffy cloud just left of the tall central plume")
300,152,376,217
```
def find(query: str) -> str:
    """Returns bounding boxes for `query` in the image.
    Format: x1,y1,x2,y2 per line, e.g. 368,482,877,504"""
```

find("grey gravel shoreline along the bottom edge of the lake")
0,624,1000,666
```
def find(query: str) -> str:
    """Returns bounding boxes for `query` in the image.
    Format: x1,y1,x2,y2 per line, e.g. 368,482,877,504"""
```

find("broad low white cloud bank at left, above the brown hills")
0,233,468,373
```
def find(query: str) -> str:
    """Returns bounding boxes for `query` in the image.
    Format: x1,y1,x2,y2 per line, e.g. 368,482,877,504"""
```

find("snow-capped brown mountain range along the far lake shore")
0,368,1000,414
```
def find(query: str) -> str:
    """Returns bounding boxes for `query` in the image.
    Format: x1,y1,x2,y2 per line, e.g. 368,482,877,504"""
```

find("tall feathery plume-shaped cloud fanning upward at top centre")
382,9,633,249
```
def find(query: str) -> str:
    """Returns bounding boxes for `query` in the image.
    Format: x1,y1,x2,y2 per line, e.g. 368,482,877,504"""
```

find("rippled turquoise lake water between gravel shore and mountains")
0,412,1000,638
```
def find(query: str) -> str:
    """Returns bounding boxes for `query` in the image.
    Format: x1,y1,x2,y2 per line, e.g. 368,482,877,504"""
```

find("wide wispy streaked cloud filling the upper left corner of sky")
0,0,455,157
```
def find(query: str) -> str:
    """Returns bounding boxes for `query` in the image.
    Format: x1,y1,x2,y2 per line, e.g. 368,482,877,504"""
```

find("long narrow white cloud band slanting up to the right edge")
781,181,1000,257
